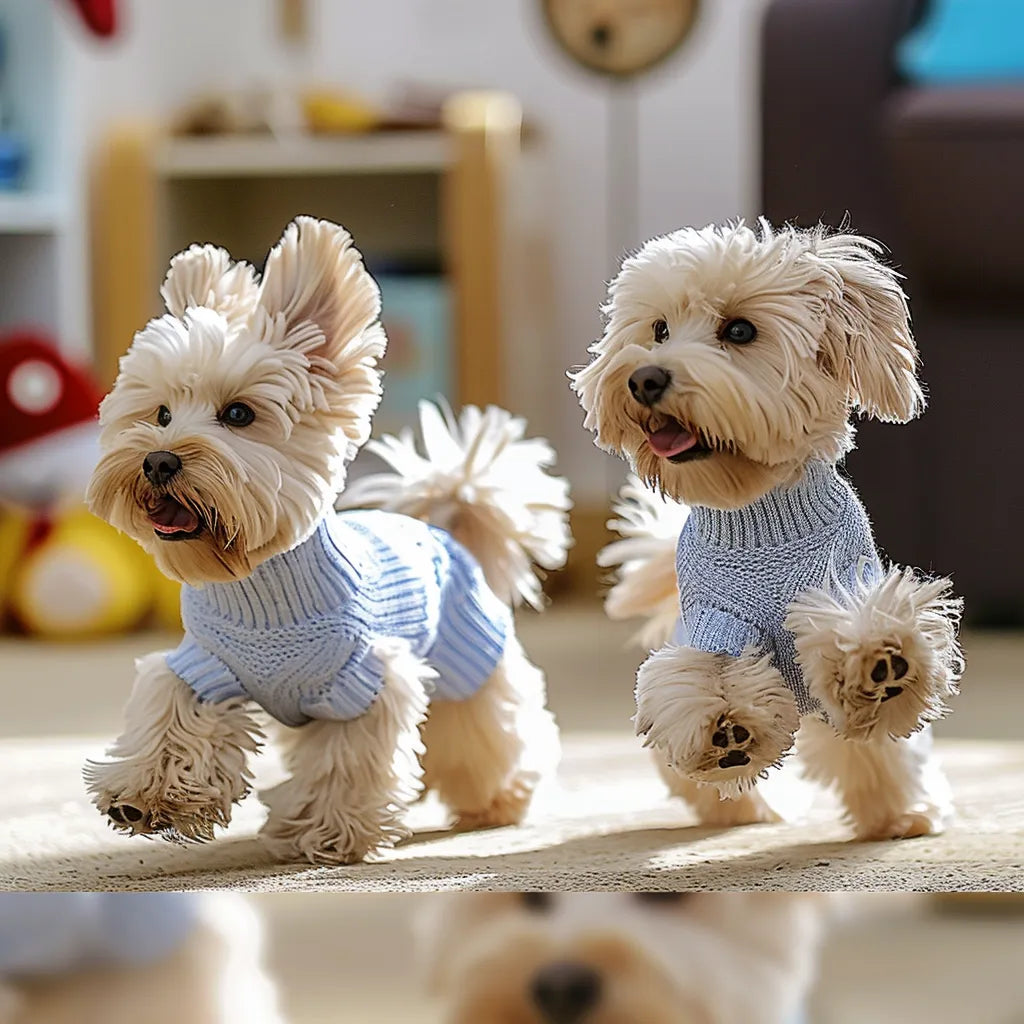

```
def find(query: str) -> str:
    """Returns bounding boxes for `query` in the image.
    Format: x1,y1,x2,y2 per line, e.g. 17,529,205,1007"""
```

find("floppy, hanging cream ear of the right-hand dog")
810,234,925,423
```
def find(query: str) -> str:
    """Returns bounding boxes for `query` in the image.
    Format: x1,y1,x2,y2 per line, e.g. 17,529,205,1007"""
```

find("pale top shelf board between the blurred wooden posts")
155,131,453,178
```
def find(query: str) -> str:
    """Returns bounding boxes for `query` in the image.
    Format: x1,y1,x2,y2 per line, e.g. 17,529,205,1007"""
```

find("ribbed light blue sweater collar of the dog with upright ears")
194,516,358,629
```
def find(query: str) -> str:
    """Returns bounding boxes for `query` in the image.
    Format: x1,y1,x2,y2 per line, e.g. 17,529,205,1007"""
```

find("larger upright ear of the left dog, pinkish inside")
255,217,387,456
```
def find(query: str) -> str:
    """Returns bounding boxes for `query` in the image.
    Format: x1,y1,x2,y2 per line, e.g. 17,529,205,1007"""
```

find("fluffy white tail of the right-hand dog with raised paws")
597,473,689,650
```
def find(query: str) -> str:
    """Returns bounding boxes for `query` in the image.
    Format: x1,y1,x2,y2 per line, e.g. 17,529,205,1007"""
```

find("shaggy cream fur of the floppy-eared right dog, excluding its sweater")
570,220,963,838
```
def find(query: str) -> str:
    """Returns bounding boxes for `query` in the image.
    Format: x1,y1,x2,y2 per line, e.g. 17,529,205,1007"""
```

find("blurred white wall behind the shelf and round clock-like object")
58,0,764,500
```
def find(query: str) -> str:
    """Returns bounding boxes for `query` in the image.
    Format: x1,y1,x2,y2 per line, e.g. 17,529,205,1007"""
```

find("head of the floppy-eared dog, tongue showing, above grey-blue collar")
572,221,924,508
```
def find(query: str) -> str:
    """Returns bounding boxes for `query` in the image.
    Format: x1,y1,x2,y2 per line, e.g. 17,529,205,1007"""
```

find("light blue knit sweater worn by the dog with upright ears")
167,512,510,725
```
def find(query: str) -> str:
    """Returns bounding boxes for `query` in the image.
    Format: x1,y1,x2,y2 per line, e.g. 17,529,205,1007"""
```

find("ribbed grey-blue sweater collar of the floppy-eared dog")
691,462,850,548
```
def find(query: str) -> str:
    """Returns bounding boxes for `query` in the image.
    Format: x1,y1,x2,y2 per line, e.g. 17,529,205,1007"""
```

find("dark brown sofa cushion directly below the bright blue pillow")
883,83,1024,304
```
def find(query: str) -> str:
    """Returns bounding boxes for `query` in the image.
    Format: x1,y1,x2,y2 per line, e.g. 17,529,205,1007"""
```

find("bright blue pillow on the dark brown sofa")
897,0,1024,84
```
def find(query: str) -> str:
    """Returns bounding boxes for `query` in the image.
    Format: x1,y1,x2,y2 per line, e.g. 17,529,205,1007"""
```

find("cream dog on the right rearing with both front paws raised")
571,221,963,840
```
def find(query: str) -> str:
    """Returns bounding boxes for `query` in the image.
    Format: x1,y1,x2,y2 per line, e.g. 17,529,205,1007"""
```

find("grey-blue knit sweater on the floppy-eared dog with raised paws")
675,462,882,714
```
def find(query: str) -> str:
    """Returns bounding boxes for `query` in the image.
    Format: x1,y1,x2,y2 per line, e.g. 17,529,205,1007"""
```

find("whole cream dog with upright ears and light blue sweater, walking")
86,217,569,863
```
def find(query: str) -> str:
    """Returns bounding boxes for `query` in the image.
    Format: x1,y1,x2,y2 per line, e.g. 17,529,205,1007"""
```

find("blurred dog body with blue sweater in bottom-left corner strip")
0,893,284,1024
